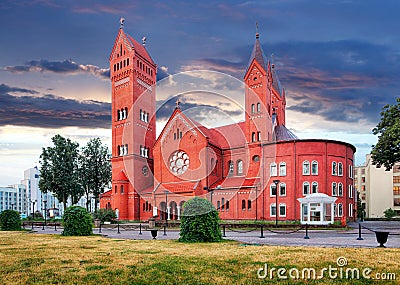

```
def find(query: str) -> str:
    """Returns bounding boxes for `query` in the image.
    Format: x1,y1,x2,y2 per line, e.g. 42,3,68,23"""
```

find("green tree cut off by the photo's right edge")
371,97,400,170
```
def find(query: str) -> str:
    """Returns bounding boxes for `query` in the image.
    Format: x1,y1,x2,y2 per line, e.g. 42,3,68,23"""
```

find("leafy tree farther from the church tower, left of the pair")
39,135,83,210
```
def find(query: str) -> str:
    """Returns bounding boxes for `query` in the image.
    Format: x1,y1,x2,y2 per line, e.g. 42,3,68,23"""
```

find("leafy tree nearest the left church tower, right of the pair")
80,138,111,211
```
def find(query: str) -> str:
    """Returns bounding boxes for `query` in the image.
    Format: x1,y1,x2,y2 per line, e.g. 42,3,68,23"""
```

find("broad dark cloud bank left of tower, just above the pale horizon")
0,84,111,128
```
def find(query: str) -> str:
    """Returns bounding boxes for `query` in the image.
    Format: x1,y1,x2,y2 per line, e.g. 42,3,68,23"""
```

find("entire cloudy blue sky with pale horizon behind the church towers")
0,0,400,186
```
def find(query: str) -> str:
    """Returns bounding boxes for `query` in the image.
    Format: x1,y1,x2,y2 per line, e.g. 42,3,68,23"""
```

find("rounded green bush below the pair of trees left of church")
62,206,93,236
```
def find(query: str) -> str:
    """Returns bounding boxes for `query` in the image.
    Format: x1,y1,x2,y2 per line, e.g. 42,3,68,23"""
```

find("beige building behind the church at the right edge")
354,154,400,218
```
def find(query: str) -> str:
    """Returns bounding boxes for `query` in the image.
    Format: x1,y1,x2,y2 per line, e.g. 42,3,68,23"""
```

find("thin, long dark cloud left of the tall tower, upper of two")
4,59,110,79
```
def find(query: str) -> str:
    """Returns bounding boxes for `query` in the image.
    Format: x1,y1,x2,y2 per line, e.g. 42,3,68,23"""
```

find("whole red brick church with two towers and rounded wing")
100,21,356,224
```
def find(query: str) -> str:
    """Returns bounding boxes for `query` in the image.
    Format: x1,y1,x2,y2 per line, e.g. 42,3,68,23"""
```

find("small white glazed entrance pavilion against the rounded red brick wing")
297,193,337,225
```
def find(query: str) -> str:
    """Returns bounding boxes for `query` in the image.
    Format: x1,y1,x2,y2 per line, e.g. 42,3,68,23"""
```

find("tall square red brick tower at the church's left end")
110,19,157,220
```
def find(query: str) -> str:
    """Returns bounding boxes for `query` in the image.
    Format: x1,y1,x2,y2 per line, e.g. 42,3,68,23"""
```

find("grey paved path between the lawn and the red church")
25,222,400,248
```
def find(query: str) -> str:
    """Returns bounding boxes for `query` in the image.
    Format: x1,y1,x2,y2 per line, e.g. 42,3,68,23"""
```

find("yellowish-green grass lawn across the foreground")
0,232,400,284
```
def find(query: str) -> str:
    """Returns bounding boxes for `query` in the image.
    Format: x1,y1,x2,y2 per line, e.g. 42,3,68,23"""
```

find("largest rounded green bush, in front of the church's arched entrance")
179,197,222,242
